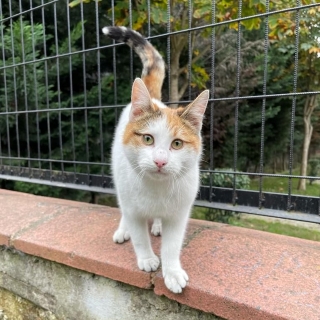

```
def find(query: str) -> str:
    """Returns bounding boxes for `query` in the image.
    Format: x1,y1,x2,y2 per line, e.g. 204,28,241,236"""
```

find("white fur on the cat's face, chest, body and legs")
112,93,206,293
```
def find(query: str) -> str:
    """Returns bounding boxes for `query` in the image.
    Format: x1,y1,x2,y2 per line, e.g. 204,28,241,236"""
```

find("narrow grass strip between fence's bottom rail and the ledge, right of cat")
191,207,320,241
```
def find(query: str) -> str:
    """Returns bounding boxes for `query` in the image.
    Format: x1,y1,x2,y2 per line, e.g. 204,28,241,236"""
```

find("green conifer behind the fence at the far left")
0,20,57,162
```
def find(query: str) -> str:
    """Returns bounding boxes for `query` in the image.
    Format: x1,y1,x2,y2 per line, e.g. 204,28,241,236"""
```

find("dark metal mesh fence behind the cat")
0,0,320,222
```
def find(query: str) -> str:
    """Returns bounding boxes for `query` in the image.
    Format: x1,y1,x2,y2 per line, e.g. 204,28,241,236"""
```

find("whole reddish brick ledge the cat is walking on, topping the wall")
0,189,320,320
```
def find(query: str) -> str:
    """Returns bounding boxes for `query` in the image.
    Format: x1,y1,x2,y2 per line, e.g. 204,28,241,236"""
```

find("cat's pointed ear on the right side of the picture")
181,90,209,132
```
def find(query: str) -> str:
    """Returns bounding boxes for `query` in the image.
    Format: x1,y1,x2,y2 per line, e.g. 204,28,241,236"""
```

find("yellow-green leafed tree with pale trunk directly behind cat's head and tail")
70,0,265,102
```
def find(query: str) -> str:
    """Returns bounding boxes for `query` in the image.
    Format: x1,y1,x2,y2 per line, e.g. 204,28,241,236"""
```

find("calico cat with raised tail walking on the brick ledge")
102,27,209,293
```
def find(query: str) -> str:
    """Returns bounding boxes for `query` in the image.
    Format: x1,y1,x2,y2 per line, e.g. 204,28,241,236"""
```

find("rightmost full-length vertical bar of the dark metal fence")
287,0,301,211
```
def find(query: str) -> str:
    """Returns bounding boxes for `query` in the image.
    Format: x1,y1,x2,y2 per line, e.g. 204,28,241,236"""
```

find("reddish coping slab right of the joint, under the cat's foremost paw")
155,221,320,320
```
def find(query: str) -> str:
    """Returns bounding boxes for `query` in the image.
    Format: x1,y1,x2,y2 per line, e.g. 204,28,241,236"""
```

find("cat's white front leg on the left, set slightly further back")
126,216,160,272
